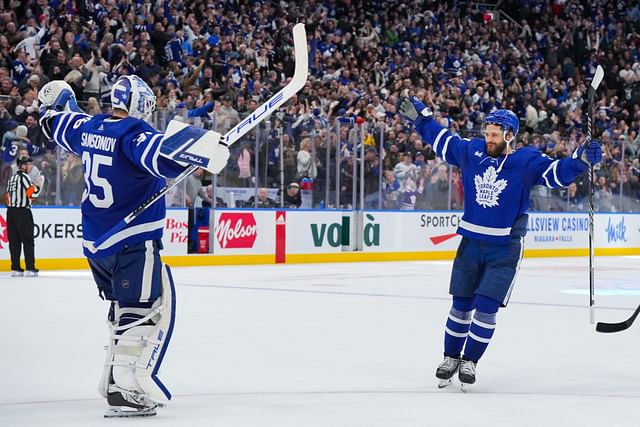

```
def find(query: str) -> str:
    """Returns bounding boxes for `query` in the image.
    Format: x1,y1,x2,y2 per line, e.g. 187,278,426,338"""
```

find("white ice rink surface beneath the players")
0,257,640,427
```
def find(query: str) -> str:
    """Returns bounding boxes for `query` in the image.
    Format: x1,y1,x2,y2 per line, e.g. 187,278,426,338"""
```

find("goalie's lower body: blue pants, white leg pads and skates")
90,241,175,417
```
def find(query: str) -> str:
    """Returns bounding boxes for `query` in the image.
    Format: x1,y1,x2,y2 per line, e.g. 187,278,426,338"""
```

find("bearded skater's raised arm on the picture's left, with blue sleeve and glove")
398,96,468,166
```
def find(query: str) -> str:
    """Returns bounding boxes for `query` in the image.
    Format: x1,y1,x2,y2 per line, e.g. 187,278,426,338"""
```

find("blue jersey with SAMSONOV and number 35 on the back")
51,113,184,258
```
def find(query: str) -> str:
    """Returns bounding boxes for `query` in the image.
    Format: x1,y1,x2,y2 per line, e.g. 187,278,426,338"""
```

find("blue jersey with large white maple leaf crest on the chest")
416,119,588,243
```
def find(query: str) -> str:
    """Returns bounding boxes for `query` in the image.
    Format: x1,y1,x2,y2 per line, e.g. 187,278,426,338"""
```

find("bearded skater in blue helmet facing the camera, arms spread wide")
399,97,602,391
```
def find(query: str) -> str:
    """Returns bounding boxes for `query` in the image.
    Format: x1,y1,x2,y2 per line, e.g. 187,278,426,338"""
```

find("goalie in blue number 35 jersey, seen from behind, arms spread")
38,76,229,417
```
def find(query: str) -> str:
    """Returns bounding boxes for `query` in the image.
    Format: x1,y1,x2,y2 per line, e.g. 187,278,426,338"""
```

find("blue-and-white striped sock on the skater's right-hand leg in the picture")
464,295,500,363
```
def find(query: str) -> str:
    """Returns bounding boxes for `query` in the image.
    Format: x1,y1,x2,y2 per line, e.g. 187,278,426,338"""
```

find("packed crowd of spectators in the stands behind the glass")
0,0,640,211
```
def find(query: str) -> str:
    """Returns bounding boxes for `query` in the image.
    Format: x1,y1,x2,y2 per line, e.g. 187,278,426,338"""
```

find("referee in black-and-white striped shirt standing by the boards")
6,157,40,277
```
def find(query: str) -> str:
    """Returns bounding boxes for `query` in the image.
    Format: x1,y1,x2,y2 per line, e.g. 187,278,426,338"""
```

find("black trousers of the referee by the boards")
7,208,36,271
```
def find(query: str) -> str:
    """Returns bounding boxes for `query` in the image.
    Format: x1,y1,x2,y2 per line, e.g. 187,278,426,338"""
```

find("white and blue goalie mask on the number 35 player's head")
111,76,156,120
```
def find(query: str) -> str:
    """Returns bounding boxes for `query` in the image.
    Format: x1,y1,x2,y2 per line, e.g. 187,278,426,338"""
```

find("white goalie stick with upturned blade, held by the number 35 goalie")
87,23,309,253
